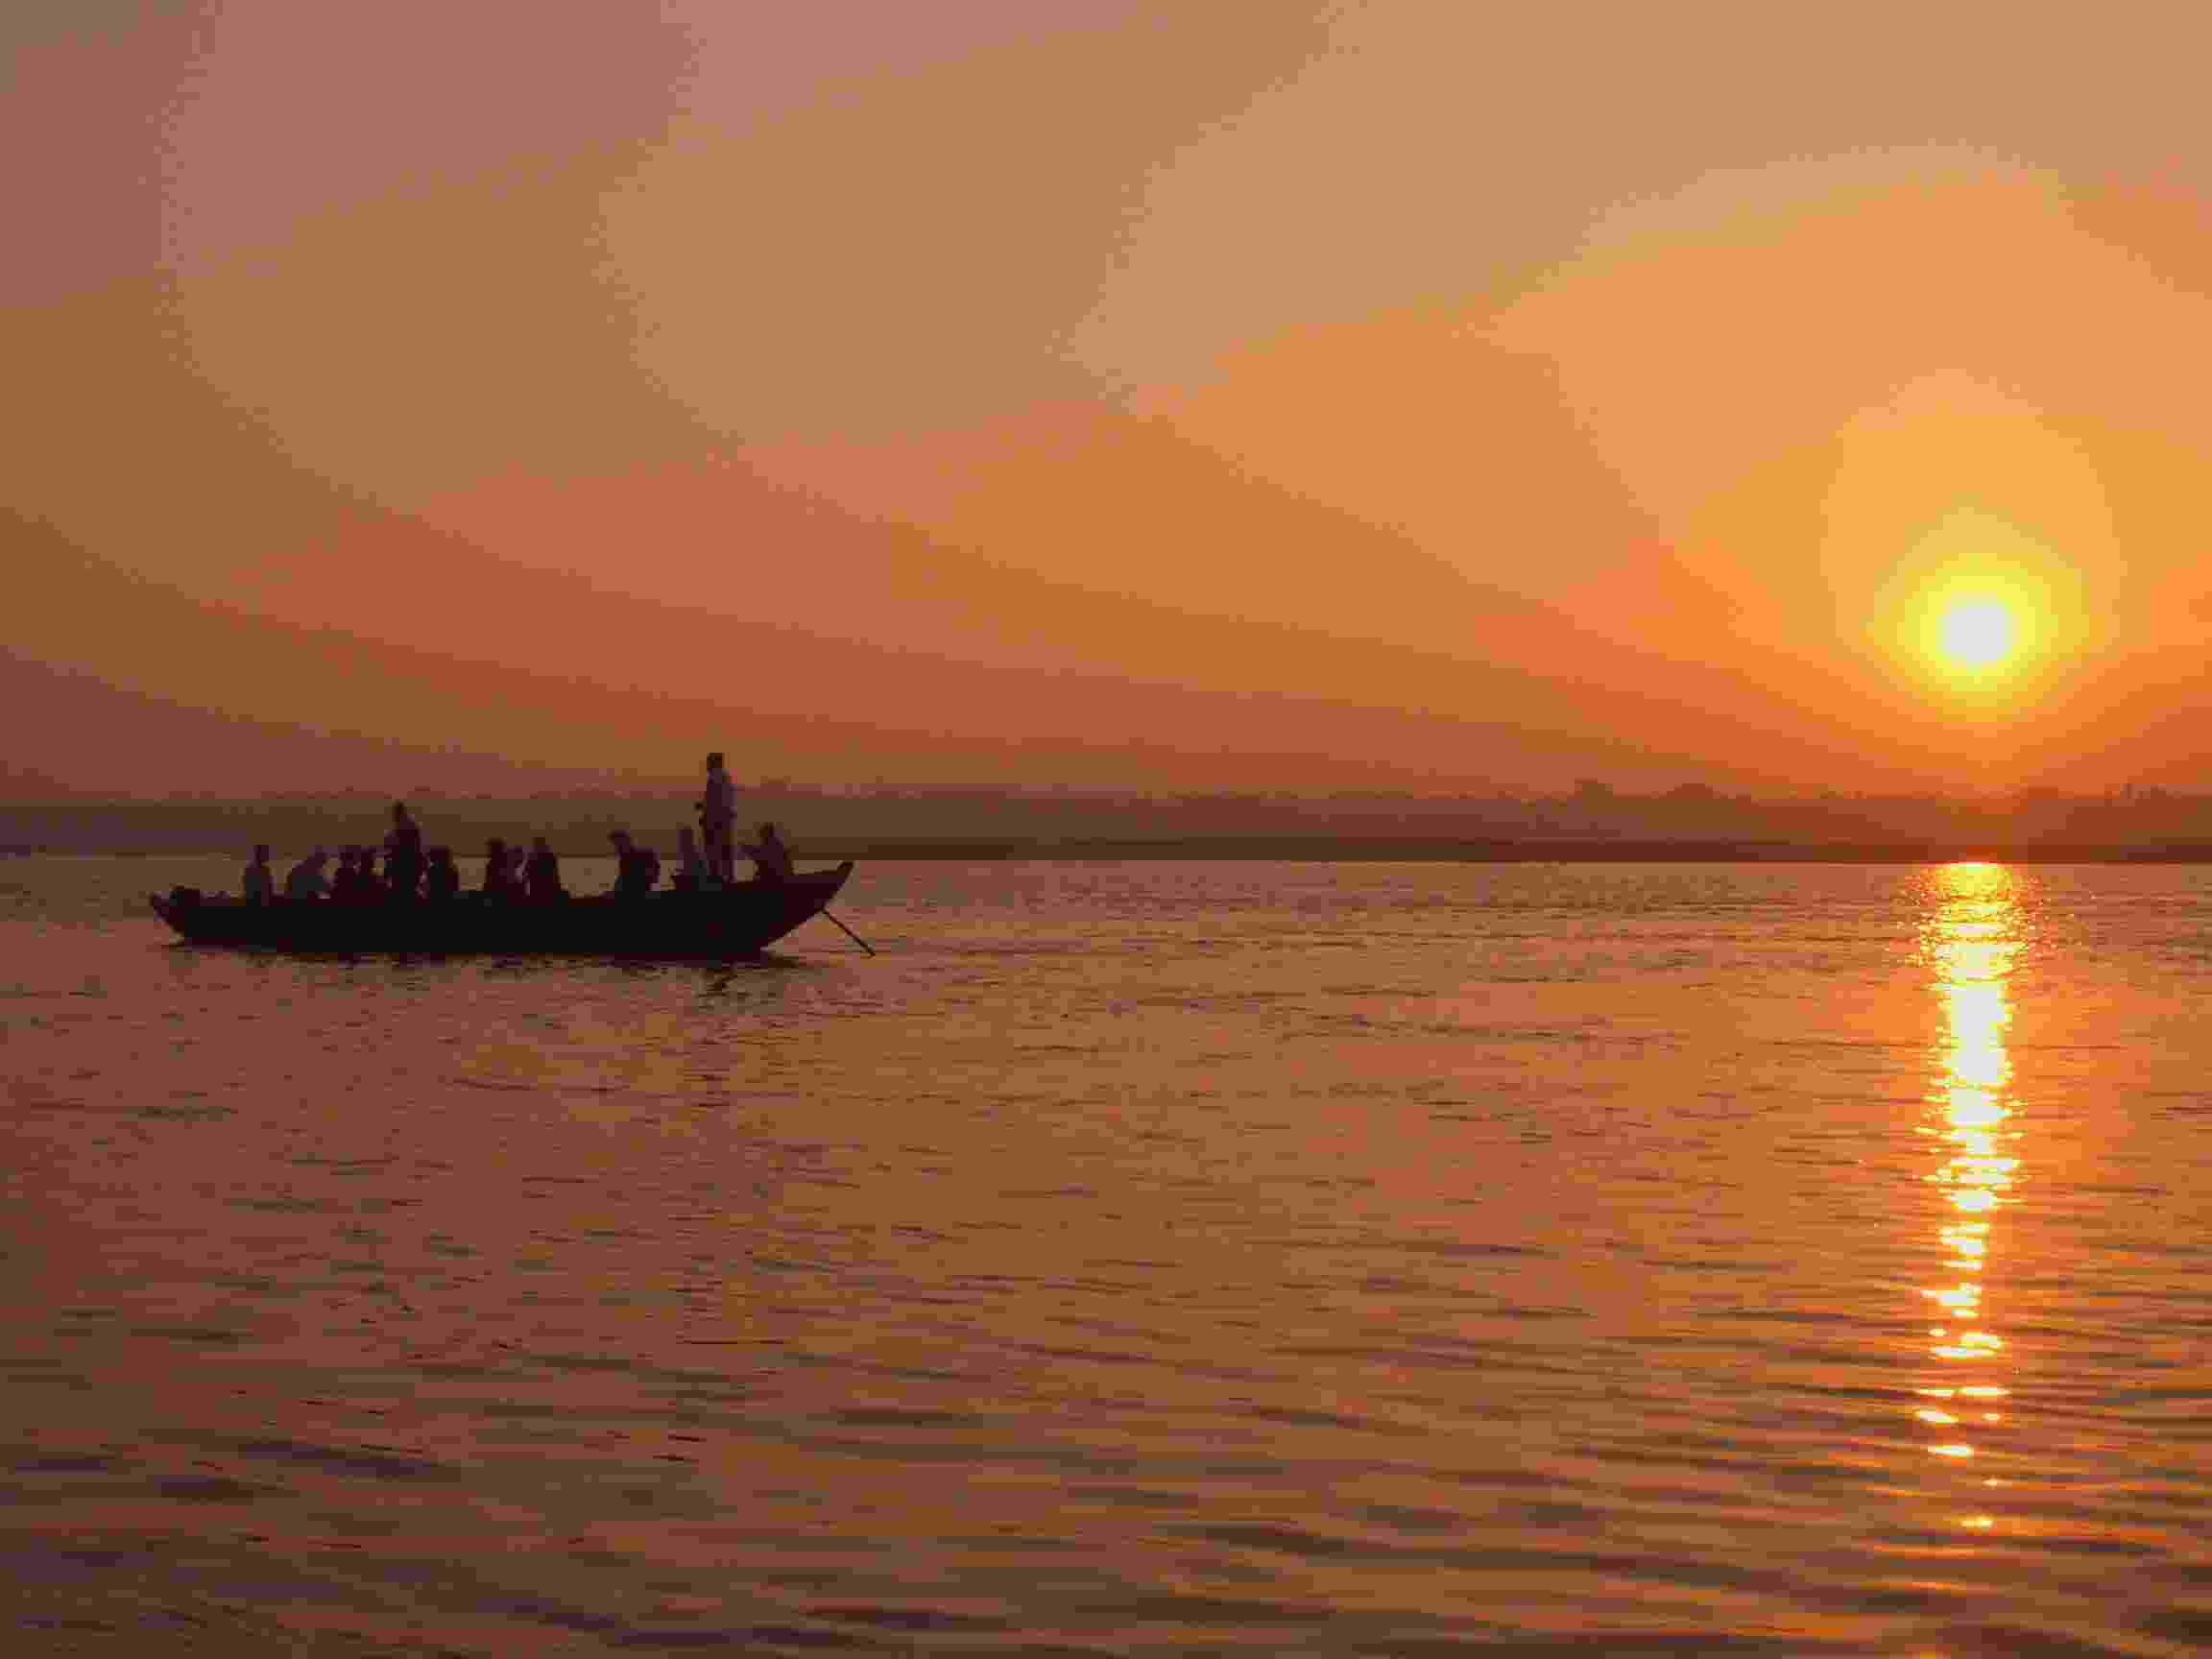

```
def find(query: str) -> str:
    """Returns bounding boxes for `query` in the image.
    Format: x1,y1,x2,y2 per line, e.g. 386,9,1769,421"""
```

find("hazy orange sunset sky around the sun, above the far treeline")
12,0,2212,792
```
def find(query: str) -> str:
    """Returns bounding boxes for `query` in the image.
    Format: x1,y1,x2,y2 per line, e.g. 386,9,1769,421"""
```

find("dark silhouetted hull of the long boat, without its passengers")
148,860,852,958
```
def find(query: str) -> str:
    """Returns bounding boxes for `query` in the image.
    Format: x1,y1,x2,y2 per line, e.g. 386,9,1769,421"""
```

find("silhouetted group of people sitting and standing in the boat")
239,750,796,904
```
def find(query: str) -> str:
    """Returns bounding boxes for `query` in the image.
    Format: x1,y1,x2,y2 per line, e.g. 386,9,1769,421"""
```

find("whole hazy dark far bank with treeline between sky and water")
12,779,2212,858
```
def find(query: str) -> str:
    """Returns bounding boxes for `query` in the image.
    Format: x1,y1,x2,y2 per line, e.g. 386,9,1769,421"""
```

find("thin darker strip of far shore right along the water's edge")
21,836,2212,865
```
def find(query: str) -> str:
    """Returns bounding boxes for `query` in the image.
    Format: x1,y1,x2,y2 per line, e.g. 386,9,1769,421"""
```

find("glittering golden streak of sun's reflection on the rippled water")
1915,865,2026,1528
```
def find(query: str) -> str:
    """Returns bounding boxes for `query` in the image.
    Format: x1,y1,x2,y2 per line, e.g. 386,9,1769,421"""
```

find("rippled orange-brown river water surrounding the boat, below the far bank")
0,858,2212,1657
